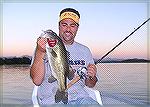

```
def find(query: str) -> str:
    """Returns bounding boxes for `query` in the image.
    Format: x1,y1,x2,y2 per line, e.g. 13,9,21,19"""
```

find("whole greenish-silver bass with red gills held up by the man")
44,30,73,104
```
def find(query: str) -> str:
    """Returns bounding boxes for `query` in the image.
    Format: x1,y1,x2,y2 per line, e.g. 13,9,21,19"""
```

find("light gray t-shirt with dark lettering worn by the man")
34,42,94,104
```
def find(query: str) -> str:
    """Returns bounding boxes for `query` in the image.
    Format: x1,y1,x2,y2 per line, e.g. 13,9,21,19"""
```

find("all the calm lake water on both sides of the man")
0,63,150,105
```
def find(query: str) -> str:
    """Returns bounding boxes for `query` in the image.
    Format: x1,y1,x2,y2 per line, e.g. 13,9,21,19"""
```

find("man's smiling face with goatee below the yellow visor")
59,19,78,45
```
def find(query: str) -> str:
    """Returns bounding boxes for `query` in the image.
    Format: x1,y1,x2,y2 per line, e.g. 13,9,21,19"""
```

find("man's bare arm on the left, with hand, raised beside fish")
30,37,46,86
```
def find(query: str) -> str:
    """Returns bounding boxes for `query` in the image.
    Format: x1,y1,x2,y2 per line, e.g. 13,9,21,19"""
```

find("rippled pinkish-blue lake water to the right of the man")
95,63,150,105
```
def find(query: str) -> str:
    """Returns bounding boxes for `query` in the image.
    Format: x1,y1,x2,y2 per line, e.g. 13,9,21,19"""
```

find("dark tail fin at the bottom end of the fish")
55,90,68,104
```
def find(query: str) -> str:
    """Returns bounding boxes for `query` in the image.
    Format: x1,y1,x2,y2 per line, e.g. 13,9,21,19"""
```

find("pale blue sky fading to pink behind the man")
2,2,149,59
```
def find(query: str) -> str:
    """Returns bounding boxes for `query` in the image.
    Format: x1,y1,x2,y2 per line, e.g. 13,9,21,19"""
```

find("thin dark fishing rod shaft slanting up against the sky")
95,18,150,64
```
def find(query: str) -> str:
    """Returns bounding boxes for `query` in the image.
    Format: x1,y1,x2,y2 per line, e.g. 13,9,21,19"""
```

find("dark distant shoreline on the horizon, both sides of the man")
0,56,150,65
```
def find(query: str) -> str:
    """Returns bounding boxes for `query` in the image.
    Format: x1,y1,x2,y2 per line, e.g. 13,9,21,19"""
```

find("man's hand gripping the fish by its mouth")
37,37,47,53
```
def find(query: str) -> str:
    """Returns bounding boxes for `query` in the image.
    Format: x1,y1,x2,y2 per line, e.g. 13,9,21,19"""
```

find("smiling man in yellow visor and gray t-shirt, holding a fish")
30,8,98,104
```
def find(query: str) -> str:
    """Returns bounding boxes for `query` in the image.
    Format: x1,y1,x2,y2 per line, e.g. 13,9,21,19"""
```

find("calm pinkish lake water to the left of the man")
0,65,34,104
